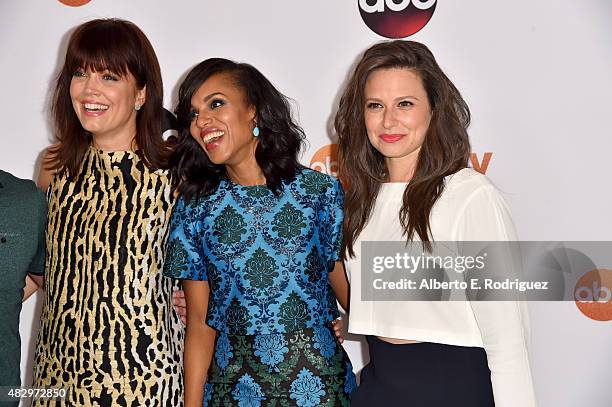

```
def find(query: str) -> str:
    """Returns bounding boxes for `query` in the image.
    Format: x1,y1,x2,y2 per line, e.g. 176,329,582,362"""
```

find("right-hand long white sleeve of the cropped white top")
455,184,536,407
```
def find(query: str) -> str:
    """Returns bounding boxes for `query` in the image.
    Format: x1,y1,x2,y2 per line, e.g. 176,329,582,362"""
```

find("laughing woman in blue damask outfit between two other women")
165,58,355,406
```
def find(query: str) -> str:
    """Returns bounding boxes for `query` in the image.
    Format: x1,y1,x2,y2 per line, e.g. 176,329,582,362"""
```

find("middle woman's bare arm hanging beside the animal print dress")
183,280,216,407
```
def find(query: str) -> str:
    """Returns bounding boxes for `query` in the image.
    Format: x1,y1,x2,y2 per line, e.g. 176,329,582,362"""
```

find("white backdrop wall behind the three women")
0,0,612,407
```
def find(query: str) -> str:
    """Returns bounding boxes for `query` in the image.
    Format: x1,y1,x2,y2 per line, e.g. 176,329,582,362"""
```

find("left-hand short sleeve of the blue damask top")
164,198,208,280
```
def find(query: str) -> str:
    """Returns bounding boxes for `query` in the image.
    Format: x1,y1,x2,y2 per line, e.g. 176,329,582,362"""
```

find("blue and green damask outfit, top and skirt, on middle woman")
165,168,355,407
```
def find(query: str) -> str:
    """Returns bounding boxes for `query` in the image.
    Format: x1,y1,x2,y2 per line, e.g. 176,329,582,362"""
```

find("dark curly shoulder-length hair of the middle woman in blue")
170,58,305,200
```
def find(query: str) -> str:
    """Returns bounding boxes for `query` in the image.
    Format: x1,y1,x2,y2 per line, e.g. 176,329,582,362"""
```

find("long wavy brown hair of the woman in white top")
334,40,470,258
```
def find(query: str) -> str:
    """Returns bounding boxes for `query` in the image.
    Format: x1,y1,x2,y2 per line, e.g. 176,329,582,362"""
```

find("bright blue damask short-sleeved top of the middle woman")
165,168,343,336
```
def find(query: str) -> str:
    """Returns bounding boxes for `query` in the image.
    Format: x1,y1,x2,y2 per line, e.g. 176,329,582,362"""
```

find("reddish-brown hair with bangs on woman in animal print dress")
45,19,169,177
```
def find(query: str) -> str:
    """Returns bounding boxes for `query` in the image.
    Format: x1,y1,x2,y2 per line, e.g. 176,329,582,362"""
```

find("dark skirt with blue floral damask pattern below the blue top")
204,327,356,407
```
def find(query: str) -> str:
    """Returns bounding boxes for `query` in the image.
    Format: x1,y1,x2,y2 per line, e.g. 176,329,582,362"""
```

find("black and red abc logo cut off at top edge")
359,0,437,38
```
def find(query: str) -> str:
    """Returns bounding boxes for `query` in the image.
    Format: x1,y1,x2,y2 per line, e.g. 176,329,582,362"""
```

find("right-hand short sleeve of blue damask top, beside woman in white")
319,178,344,266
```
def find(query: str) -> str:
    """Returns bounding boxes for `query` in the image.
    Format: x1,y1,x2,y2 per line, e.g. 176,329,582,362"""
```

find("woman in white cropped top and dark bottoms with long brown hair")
335,41,536,407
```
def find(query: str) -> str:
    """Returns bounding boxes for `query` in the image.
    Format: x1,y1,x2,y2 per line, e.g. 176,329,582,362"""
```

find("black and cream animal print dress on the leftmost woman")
34,147,183,407
